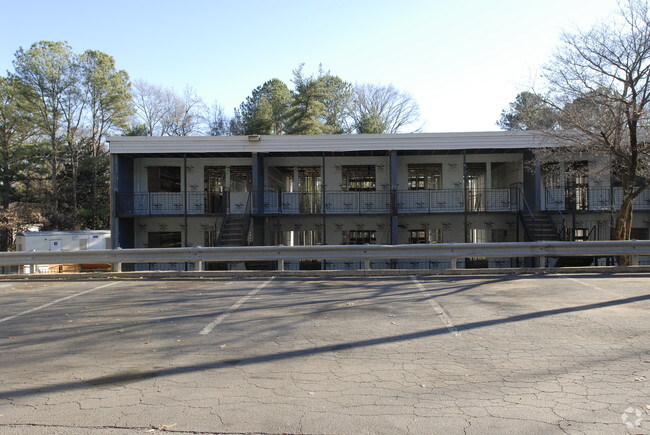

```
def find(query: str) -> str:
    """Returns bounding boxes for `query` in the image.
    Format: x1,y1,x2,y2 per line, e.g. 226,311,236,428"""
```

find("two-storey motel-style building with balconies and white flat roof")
109,131,650,269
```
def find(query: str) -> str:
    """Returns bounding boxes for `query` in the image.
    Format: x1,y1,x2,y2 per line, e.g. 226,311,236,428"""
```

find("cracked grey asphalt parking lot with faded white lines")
0,274,650,435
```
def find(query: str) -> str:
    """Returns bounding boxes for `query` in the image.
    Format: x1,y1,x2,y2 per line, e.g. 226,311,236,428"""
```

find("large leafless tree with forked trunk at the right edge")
544,0,650,245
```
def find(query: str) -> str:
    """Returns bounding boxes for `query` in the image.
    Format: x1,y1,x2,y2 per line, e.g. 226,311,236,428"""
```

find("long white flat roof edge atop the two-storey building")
108,131,548,154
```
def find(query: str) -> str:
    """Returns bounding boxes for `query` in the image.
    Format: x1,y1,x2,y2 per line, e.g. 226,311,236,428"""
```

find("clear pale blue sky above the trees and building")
0,0,617,132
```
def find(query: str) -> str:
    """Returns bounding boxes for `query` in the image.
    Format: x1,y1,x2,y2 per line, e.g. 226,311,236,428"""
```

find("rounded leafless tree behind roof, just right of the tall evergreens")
350,84,420,133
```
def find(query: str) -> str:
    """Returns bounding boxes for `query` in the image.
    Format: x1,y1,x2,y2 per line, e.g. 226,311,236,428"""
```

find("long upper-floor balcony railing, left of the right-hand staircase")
116,189,519,216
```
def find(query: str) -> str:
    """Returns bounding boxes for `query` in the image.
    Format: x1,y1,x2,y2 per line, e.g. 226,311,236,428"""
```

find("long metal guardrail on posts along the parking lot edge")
0,240,650,272
